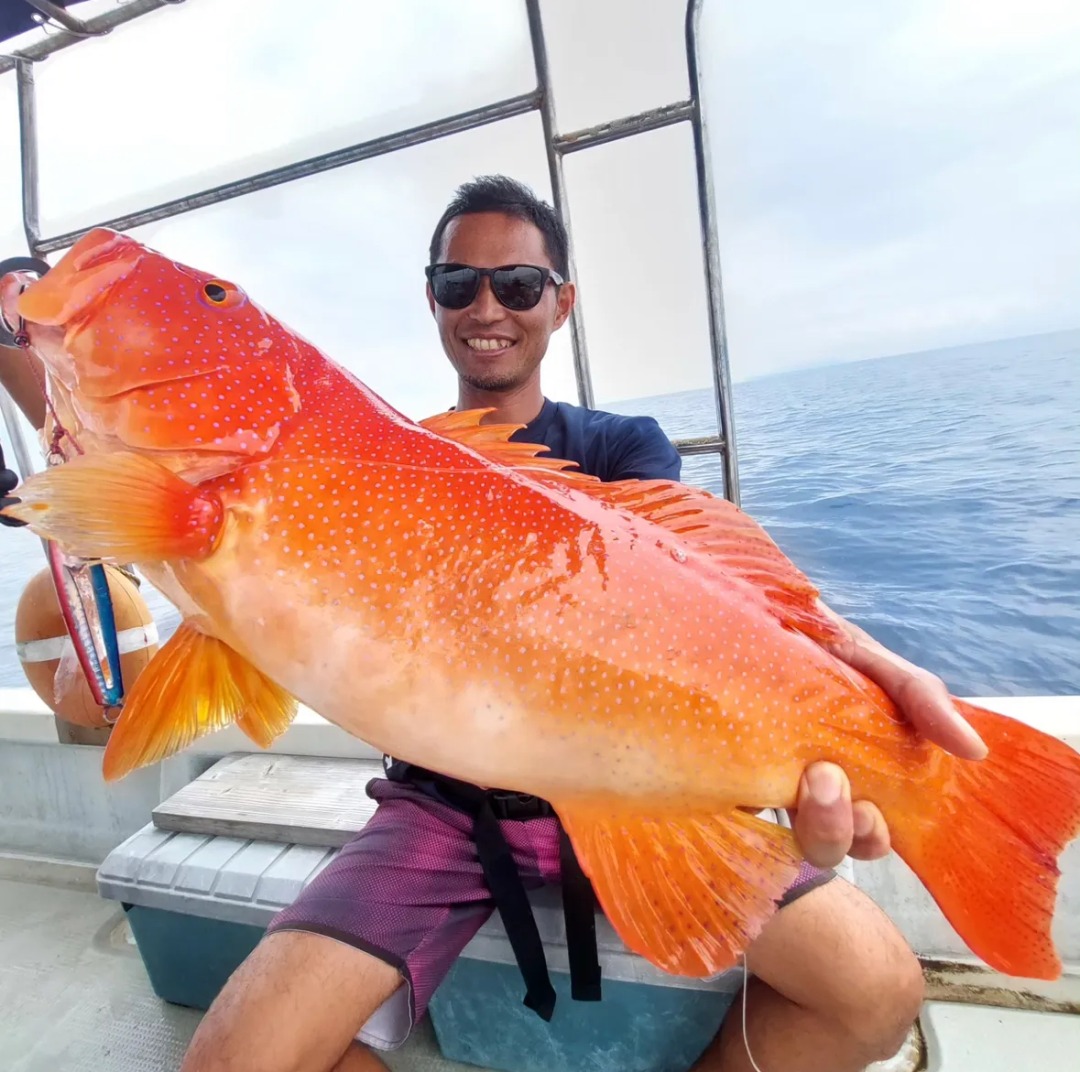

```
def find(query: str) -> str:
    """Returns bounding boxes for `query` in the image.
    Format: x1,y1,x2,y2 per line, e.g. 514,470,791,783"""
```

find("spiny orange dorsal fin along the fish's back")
420,409,843,641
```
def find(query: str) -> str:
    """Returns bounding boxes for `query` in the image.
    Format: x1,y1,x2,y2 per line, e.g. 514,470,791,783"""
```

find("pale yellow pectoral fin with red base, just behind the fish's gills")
3,452,224,562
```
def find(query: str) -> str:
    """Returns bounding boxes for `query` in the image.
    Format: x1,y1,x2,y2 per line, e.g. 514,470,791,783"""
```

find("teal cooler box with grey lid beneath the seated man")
97,824,742,1072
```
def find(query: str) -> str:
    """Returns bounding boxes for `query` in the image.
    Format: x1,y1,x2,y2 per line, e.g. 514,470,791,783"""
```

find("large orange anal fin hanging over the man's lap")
555,800,801,978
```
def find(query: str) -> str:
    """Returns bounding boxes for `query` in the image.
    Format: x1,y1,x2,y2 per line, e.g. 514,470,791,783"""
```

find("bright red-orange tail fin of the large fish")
885,700,1080,979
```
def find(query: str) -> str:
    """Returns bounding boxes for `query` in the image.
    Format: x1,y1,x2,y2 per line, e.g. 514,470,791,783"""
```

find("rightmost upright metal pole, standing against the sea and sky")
686,0,740,505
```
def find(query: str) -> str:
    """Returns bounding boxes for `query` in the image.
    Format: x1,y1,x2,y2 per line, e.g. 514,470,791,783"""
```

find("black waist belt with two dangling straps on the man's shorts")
386,760,600,1020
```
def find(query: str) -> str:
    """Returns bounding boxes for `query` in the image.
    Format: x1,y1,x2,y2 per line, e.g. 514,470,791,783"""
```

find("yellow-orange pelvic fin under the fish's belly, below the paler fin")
103,622,297,782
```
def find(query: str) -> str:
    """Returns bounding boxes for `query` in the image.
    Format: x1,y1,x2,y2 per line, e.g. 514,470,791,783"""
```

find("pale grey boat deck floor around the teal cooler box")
0,878,1080,1072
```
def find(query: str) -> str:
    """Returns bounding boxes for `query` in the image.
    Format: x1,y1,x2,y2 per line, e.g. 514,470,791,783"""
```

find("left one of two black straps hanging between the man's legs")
473,797,555,1020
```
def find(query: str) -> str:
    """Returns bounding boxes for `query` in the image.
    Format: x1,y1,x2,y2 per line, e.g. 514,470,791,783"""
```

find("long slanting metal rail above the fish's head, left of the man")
36,90,540,254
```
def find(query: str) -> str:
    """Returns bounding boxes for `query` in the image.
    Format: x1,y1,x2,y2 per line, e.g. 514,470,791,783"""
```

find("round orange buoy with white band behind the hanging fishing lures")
15,566,159,728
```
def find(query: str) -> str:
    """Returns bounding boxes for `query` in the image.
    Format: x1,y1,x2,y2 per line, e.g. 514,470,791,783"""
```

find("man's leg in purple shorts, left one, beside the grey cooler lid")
181,779,511,1072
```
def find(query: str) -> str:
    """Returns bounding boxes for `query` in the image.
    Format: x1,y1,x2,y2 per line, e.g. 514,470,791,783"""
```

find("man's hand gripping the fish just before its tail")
791,603,987,867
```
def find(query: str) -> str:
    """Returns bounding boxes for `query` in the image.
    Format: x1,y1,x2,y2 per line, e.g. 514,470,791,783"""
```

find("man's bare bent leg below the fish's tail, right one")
694,879,922,1072
